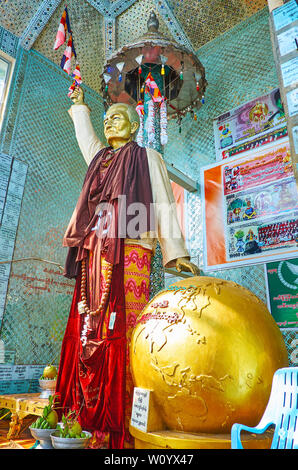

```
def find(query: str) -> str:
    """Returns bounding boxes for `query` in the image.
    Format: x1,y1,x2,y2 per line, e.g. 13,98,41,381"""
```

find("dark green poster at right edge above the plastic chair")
264,258,298,328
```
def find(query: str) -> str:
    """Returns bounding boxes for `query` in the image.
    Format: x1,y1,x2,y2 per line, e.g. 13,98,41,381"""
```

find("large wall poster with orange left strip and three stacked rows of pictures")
201,137,298,271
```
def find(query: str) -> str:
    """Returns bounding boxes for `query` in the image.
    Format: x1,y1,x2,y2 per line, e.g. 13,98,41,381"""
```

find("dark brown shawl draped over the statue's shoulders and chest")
63,142,155,278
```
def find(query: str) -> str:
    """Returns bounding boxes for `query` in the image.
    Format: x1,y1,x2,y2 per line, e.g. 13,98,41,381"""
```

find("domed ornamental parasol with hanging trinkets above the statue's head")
101,12,207,118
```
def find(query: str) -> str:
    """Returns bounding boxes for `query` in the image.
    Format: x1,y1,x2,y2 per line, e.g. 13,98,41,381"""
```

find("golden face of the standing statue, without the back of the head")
104,104,136,148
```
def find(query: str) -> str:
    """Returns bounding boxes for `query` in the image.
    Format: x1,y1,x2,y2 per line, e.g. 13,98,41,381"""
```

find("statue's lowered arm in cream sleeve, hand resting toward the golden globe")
146,148,200,275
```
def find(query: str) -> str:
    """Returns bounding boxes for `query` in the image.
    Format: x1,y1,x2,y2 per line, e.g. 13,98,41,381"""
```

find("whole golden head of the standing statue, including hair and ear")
104,103,140,148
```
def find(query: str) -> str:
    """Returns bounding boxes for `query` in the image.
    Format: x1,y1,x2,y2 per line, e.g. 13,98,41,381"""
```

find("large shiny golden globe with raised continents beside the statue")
130,277,288,433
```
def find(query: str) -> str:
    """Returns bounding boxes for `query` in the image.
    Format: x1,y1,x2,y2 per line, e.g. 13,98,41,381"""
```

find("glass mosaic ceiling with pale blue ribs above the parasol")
0,0,267,92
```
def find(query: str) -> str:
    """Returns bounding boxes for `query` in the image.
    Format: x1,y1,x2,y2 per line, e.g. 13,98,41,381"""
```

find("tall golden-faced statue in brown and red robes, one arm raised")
56,88,199,449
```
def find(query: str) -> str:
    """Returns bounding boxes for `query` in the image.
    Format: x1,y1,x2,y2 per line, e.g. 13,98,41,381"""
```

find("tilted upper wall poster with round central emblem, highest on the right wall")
213,88,288,161
